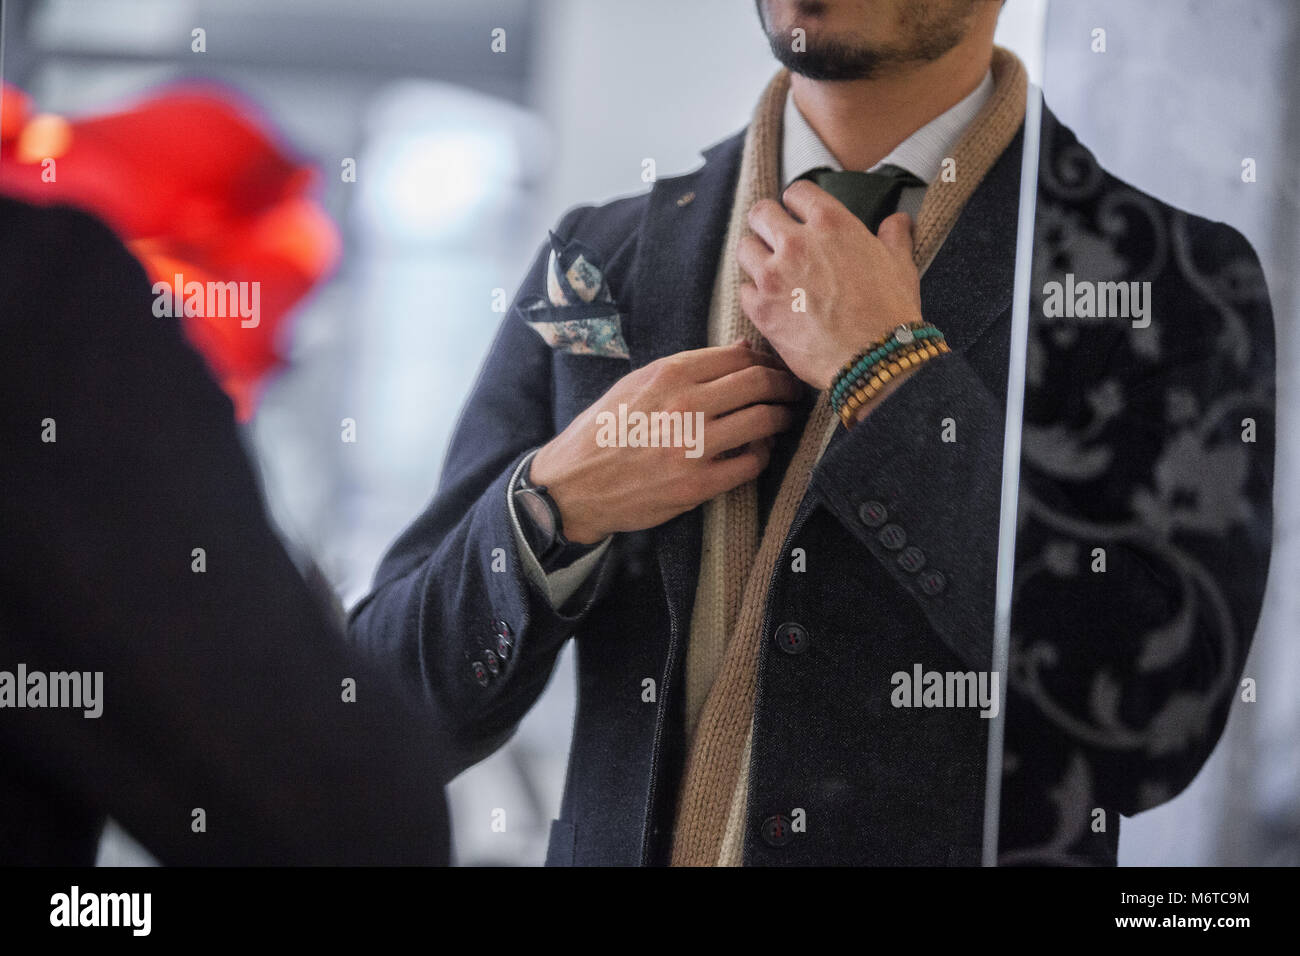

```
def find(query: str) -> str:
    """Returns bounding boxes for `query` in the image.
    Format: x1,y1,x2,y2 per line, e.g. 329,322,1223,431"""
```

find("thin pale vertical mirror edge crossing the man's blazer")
983,0,1050,866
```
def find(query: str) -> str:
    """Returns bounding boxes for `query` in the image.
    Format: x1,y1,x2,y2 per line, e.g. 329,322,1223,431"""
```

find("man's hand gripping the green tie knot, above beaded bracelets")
738,179,920,389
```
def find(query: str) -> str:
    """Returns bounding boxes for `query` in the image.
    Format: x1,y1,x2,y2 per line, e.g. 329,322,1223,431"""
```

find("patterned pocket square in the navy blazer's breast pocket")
516,233,628,359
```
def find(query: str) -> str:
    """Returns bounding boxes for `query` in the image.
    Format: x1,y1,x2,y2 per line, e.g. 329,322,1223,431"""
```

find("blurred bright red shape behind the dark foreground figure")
0,86,341,421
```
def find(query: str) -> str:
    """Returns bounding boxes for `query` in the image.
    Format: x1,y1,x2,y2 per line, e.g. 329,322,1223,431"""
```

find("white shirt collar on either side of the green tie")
781,70,993,186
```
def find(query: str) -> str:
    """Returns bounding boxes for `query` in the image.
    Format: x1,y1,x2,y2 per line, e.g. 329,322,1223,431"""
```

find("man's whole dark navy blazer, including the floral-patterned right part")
351,104,1273,865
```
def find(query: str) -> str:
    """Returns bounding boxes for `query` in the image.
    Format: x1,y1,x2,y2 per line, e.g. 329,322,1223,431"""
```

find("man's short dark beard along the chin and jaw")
757,0,975,79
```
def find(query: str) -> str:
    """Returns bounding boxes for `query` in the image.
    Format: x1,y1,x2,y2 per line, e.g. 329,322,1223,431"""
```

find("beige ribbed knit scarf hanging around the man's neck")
672,47,1027,866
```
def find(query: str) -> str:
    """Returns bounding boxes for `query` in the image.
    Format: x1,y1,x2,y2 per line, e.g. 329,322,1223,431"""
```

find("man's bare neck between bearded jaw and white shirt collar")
790,38,993,169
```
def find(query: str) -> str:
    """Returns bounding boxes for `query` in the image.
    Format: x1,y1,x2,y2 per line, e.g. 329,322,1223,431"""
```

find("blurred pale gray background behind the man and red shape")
3,0,1300,865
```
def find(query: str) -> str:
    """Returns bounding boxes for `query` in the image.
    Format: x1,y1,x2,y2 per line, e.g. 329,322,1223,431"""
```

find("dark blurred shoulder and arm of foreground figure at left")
0,199,449,865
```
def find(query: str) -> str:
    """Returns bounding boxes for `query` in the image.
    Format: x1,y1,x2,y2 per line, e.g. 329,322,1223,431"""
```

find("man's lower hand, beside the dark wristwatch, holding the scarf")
530,341,802,544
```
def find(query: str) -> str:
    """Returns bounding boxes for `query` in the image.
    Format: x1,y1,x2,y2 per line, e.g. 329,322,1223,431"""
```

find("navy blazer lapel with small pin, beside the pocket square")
624,131,745,642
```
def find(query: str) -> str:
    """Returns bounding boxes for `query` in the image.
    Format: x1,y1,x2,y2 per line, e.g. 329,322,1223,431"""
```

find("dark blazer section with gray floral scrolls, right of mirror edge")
1001,113,1274,864
